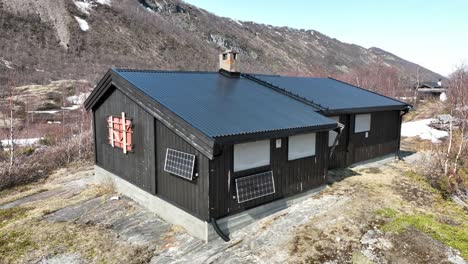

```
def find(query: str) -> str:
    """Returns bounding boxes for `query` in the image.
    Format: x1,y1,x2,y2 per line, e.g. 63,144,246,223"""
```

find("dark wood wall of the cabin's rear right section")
347,111,400,165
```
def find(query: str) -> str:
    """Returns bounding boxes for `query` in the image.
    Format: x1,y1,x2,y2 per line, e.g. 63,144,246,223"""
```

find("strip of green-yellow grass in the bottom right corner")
383,214,468,259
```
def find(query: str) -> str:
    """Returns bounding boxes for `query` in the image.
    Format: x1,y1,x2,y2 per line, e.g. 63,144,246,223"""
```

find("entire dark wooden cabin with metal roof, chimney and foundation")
85,52,409,241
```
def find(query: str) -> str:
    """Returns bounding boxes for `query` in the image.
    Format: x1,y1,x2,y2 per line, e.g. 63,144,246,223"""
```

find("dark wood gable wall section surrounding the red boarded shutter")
93,88,156,194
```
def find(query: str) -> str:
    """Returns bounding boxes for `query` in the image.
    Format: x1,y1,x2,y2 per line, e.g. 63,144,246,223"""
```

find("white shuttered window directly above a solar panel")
234,140,270,172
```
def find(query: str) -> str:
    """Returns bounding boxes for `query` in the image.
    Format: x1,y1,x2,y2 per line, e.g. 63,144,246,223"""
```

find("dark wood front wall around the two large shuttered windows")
210,132,328,218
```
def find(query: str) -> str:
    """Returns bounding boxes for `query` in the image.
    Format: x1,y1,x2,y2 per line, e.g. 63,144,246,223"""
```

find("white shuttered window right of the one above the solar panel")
288,133,315,160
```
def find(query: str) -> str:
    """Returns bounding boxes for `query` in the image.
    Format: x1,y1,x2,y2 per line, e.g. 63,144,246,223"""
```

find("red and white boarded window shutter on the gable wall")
107,113,133,153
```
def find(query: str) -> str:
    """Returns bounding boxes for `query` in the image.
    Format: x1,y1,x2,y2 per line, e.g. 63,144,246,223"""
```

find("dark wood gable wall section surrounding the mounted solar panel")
156,121,209,220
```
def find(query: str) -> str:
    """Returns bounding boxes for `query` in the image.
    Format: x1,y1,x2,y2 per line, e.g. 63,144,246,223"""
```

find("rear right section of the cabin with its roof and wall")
245,75,410,169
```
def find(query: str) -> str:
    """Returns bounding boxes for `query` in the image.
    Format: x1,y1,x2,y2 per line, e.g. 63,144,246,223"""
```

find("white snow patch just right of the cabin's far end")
401,118,448,143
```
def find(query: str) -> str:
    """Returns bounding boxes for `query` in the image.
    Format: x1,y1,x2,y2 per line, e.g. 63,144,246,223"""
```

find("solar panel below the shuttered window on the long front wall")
236,171,275,203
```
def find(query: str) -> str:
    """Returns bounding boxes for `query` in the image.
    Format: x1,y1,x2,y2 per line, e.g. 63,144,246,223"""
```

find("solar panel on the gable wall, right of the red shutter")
164,148,195,180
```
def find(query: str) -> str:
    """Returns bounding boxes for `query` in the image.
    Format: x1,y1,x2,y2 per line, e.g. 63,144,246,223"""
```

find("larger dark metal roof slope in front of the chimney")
113,69,336,137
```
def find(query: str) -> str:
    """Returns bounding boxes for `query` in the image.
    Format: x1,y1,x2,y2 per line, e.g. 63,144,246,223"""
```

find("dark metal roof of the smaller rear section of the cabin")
253,74,407,111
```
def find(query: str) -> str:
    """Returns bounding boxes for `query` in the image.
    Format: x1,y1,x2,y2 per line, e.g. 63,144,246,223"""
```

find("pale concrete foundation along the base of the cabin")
95,165,326,242
